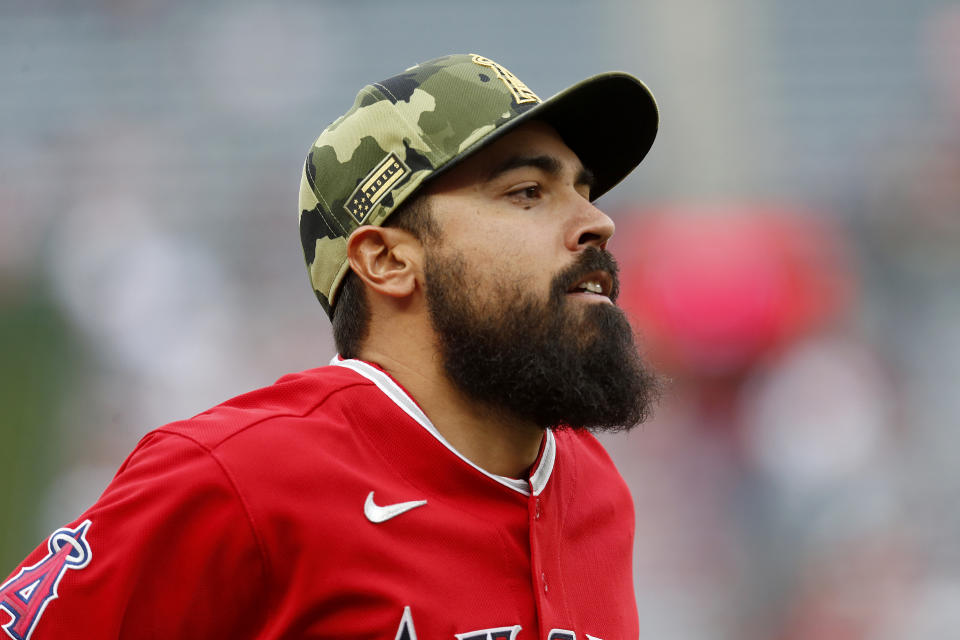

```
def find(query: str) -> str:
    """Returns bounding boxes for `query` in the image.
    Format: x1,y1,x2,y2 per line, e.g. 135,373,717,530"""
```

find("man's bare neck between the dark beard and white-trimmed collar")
360,340,543,478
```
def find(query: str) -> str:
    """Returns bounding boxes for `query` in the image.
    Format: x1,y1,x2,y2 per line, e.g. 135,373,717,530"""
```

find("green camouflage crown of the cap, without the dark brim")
300,54,540,315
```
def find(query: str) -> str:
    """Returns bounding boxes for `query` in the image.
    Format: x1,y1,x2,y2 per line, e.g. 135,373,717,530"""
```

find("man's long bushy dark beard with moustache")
425,247,660,432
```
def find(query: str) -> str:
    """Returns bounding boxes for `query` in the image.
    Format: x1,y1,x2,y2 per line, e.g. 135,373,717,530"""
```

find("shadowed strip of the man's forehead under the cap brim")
427,121,583,193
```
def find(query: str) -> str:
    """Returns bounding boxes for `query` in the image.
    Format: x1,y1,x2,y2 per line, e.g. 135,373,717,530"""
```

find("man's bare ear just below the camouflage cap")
347,225,423,298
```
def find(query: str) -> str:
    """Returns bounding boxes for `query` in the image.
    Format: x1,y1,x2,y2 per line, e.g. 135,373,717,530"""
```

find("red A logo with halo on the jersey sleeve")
0,520,93,640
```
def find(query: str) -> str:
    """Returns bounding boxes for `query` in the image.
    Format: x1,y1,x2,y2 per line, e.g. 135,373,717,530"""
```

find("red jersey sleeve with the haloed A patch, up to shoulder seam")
0,432,268,640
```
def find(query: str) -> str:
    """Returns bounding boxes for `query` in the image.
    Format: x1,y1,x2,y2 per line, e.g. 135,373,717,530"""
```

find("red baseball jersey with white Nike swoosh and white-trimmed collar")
0,360,638,640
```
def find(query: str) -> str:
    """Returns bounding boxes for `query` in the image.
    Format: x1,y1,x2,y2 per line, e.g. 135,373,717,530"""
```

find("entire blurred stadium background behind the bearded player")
0,0,960,640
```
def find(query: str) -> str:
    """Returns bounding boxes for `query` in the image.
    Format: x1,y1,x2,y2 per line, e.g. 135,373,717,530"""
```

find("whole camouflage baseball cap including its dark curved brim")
300,54,658,317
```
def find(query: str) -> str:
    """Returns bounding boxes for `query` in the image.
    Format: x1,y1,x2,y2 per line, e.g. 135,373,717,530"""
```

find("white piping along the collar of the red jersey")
330,356,557,496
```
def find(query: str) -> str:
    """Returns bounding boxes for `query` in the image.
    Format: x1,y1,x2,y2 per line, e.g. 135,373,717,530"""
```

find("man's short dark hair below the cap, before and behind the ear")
332,195,440,358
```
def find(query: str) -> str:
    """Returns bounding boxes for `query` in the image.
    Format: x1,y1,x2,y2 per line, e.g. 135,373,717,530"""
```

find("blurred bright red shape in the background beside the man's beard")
615,205,852,379
